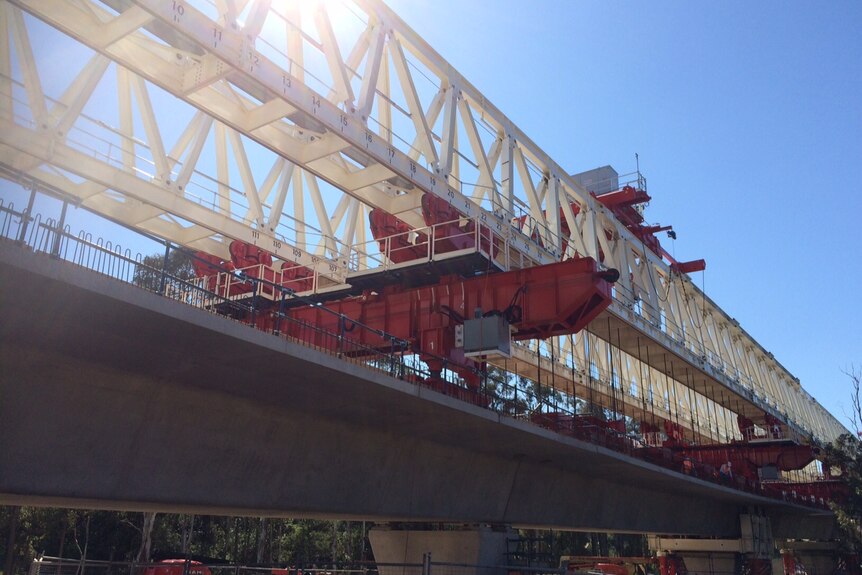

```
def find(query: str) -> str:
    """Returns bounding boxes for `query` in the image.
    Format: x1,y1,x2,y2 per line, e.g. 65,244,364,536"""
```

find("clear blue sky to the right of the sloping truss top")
387,0,862,424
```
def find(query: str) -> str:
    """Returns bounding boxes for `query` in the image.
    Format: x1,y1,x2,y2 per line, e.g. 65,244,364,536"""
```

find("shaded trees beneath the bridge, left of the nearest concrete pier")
0,507,371,574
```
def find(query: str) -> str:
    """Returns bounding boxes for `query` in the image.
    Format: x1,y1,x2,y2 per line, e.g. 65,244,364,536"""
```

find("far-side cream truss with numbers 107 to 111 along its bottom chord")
2,3,384,279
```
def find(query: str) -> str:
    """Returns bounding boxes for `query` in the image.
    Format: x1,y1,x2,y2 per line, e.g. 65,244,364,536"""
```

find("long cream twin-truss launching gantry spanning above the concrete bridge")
0,0,844,440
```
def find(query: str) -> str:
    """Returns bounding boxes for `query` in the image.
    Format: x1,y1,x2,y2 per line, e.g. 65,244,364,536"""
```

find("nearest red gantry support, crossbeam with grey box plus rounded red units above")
194,201,619,395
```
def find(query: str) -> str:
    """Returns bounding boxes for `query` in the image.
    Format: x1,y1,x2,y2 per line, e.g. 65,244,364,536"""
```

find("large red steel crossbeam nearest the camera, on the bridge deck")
285,258,618,387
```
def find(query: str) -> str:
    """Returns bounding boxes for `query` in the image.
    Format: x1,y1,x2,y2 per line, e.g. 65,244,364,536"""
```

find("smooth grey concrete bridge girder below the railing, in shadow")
0,242,831,537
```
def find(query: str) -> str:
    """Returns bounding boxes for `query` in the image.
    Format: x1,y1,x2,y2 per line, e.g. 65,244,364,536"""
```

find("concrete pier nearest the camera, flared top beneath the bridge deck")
368,525,516,575
